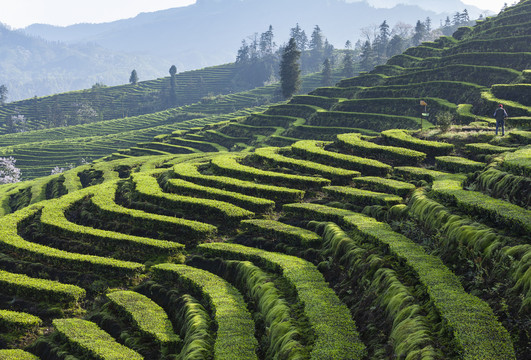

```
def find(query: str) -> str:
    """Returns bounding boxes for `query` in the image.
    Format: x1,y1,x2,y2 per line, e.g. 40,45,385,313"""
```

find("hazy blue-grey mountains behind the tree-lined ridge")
0,0,480,101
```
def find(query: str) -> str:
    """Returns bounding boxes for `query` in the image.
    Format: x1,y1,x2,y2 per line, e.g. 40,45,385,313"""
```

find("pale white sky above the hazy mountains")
0,0,513,28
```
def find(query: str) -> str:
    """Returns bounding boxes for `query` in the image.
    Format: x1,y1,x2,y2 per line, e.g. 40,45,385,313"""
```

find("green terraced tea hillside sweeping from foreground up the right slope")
0,0,531,360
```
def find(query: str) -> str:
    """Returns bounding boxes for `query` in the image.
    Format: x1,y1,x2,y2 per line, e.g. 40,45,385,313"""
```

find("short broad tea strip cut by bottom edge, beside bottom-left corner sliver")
53,319,143,360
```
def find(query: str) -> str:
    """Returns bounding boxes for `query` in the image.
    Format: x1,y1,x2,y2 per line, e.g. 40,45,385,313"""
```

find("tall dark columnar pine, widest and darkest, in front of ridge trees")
280,38,301,99
